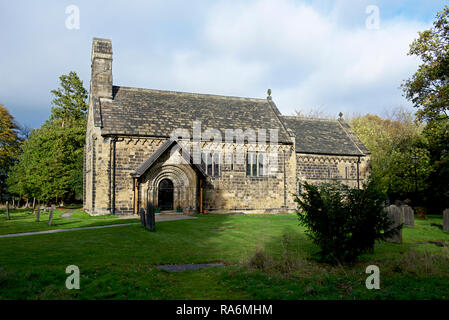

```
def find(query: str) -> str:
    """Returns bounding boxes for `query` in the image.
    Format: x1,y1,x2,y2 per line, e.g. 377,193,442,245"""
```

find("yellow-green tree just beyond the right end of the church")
350,109,430,200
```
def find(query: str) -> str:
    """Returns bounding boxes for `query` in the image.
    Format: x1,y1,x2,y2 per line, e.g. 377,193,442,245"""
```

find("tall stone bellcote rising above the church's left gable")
90,38,112,99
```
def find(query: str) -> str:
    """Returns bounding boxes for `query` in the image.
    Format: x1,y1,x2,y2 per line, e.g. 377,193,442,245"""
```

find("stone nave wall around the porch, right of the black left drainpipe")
115,138,296,214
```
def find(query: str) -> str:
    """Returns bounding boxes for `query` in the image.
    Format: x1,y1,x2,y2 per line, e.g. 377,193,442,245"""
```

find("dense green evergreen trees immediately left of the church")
8,72,87,202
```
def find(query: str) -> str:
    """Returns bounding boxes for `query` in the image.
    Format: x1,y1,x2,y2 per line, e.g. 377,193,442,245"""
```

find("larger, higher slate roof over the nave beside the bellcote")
96,86,292,143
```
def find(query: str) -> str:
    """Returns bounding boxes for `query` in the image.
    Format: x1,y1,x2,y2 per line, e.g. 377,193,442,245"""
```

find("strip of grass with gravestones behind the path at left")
0,209,137,235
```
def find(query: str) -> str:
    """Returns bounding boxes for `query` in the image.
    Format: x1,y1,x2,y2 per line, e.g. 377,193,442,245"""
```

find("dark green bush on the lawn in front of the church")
295,182,399,263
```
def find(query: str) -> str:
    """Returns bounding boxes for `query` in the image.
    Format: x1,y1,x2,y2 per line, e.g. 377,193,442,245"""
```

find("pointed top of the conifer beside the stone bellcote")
50,71,88,127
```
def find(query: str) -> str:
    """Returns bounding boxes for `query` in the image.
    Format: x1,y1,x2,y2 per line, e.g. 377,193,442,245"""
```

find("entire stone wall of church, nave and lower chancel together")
85,128,368,214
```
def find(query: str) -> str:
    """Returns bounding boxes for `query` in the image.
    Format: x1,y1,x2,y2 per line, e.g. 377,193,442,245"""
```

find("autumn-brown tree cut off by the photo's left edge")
0,104,22,200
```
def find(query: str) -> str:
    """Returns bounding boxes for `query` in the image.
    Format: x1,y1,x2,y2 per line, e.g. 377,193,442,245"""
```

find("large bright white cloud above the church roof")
160,0,428,114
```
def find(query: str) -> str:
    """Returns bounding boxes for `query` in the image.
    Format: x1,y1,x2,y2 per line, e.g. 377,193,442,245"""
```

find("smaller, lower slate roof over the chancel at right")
283,116,370,155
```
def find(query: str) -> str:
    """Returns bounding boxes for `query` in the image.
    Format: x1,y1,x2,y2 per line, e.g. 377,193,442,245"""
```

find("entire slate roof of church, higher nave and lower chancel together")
93,86,370,155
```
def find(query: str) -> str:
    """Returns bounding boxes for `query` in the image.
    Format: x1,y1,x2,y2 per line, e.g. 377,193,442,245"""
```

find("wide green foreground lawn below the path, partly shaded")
0,213,449,299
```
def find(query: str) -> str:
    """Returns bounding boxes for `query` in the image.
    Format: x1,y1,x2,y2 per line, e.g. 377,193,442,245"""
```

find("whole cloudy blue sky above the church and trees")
0,0,445,128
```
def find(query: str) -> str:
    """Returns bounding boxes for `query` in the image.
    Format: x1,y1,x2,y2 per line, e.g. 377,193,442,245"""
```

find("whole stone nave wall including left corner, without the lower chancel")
84,130,296,214
